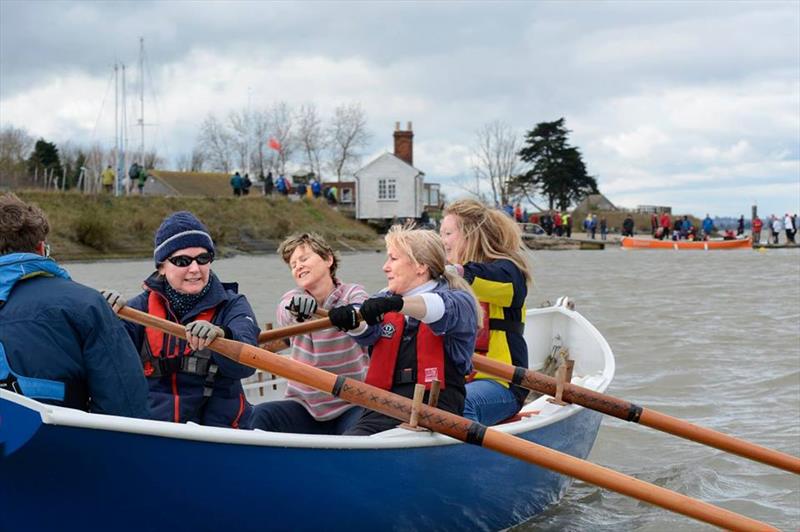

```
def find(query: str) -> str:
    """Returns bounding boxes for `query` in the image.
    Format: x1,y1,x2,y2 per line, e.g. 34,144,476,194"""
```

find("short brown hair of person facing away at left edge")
0,193,50,255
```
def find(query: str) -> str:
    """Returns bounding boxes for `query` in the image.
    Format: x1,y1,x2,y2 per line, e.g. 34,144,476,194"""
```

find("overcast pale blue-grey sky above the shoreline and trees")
0,0,800,216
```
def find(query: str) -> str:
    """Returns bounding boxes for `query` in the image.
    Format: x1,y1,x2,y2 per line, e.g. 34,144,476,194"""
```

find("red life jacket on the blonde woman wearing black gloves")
366,312,445,390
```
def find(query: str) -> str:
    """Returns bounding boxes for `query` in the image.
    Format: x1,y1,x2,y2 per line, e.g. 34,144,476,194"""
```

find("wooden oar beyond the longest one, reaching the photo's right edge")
472,355,800,474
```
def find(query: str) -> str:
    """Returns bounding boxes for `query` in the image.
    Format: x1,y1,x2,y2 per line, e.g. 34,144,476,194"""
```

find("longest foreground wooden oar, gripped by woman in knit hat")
119,307,777,530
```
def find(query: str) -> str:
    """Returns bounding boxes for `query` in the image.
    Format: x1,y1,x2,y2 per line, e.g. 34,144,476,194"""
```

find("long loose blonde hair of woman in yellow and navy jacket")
444,199,533,285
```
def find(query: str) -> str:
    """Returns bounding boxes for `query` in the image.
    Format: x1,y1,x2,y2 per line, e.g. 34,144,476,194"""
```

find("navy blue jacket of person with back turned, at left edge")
0,253,150,418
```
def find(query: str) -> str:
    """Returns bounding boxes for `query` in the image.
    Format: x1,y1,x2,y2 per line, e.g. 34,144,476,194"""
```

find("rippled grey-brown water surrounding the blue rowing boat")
66,248,800,531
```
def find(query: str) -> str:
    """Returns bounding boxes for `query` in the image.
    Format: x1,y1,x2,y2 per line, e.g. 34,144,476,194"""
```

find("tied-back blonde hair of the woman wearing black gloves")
385,225,483,323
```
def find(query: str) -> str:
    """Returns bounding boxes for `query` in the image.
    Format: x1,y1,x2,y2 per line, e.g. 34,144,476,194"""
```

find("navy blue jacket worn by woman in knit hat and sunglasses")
125,273,259,427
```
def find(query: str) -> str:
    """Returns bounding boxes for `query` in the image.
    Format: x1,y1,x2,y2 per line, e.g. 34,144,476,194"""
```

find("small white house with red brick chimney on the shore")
355,122,428,220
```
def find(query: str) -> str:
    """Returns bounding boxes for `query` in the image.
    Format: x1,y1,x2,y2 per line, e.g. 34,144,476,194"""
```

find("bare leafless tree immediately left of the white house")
328,102,370,181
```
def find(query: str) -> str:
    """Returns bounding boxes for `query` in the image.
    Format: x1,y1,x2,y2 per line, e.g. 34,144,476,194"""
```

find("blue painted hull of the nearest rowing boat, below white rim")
0,397,601,532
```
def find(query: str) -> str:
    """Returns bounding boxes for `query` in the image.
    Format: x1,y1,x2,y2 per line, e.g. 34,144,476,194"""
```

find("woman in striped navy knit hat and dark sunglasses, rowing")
103,211,259,428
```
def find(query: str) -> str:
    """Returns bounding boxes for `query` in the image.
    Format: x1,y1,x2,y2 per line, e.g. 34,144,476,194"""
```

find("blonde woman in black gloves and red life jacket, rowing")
329,226,479,435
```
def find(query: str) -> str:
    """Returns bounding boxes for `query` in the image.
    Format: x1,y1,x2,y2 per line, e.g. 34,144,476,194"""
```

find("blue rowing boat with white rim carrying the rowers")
0,298,614,531
